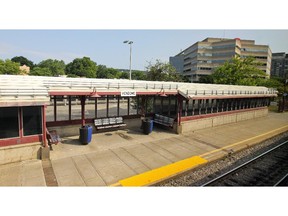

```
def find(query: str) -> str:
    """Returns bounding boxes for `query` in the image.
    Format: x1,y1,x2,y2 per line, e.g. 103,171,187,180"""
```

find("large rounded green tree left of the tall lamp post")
65,57,97,78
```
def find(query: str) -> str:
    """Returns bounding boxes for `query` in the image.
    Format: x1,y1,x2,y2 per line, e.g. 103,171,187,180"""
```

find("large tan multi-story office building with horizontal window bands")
170,38,272,82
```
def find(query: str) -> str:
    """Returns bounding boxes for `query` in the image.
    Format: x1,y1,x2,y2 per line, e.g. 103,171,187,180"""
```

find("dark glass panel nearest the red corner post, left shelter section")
22,107,42,136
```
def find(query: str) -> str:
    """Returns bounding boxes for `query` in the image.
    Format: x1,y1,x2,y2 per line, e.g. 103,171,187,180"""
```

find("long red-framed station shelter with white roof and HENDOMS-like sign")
0,75,277,162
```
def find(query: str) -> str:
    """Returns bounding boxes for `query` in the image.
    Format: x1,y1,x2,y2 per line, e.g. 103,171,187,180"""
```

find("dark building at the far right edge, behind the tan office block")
271,52,288,78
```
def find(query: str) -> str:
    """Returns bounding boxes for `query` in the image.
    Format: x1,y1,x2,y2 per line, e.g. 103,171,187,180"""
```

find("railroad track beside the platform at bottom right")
201,141,288,186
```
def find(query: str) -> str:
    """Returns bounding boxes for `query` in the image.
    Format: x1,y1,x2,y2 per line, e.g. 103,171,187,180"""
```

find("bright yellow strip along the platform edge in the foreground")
111,156,208,186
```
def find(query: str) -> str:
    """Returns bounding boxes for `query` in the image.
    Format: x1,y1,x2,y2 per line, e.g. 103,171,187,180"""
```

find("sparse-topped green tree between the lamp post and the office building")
147,60,183,82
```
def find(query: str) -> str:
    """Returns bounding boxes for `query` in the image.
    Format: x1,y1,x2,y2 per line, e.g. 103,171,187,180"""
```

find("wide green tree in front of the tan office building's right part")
211,57,267,86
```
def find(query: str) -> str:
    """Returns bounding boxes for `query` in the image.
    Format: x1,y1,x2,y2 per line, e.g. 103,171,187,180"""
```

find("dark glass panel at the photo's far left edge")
0,107,19,139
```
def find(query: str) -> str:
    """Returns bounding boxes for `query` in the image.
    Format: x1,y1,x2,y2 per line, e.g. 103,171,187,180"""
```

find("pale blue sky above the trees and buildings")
0,29,288,70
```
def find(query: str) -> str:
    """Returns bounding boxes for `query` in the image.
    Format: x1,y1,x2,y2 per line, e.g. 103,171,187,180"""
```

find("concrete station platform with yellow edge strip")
0,112,288,186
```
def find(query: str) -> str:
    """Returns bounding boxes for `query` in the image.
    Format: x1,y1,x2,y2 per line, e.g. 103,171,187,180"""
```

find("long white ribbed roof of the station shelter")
0,75,277,106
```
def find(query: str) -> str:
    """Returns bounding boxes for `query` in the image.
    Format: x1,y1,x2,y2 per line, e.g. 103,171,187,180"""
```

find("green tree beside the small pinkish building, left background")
37,59,66,76
